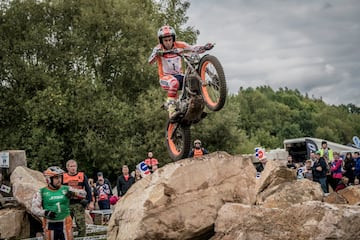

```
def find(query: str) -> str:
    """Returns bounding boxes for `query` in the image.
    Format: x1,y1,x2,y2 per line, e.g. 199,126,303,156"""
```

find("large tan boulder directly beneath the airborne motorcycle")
107,152,256,239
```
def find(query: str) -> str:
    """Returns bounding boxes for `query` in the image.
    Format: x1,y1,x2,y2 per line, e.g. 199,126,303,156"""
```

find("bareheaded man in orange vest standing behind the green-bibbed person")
63,159,94,237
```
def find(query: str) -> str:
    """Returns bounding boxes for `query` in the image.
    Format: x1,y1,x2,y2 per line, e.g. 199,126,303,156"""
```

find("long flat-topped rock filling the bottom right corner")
211,201,360,240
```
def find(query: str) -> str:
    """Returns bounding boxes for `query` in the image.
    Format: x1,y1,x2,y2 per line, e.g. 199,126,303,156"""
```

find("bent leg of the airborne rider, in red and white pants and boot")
160,75,180,119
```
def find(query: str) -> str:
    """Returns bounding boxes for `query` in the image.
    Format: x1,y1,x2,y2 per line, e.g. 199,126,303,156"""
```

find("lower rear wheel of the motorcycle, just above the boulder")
165,120,191,161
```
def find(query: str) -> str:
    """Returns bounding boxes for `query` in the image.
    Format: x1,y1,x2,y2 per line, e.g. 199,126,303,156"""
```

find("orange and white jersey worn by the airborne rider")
149,42,198,78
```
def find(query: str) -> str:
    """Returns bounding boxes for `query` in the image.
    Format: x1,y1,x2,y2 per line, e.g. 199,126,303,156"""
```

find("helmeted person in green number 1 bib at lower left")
32,166,86,240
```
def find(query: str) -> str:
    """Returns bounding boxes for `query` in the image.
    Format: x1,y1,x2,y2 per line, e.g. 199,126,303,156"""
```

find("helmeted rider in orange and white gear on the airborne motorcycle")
148,25,213,119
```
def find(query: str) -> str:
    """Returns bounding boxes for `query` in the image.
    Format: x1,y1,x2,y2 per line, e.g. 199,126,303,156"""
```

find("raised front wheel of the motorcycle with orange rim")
199,55,227,111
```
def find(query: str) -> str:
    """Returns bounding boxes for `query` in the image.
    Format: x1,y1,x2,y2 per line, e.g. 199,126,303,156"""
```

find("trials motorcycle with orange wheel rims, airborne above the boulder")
163,45,227,161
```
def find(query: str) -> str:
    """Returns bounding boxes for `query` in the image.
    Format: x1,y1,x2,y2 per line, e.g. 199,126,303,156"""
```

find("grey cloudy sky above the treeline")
187,0,360,107
